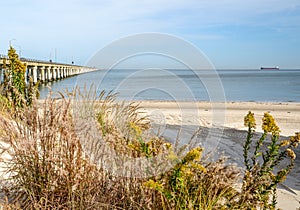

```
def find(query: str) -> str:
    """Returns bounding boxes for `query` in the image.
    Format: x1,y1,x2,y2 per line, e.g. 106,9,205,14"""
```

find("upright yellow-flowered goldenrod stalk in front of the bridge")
1,47,38,108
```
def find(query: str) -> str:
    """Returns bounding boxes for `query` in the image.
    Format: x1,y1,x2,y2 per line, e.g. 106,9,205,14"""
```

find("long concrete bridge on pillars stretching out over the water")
0,54,97,83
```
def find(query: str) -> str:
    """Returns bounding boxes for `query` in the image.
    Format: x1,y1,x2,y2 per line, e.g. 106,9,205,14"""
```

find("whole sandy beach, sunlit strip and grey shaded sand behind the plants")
140,101,300,210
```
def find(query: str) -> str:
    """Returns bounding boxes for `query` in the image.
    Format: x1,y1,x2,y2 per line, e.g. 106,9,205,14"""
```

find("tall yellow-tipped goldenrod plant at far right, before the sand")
239,112,300,209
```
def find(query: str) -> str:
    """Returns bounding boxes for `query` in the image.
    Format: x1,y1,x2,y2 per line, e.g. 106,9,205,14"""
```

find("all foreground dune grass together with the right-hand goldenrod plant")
0,86,300,209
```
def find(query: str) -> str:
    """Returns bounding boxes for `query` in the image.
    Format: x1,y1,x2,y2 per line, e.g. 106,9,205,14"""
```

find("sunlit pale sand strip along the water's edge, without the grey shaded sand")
137,101,300,136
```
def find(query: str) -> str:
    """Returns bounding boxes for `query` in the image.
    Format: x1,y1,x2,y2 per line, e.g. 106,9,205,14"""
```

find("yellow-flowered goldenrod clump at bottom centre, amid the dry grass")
144,147,238,209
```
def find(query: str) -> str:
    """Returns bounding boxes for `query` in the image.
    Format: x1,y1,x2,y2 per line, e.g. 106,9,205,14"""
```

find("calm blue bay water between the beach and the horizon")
39,69,300,102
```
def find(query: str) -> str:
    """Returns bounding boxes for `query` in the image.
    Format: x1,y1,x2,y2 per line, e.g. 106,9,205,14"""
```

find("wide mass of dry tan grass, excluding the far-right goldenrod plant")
0,90,296,209
